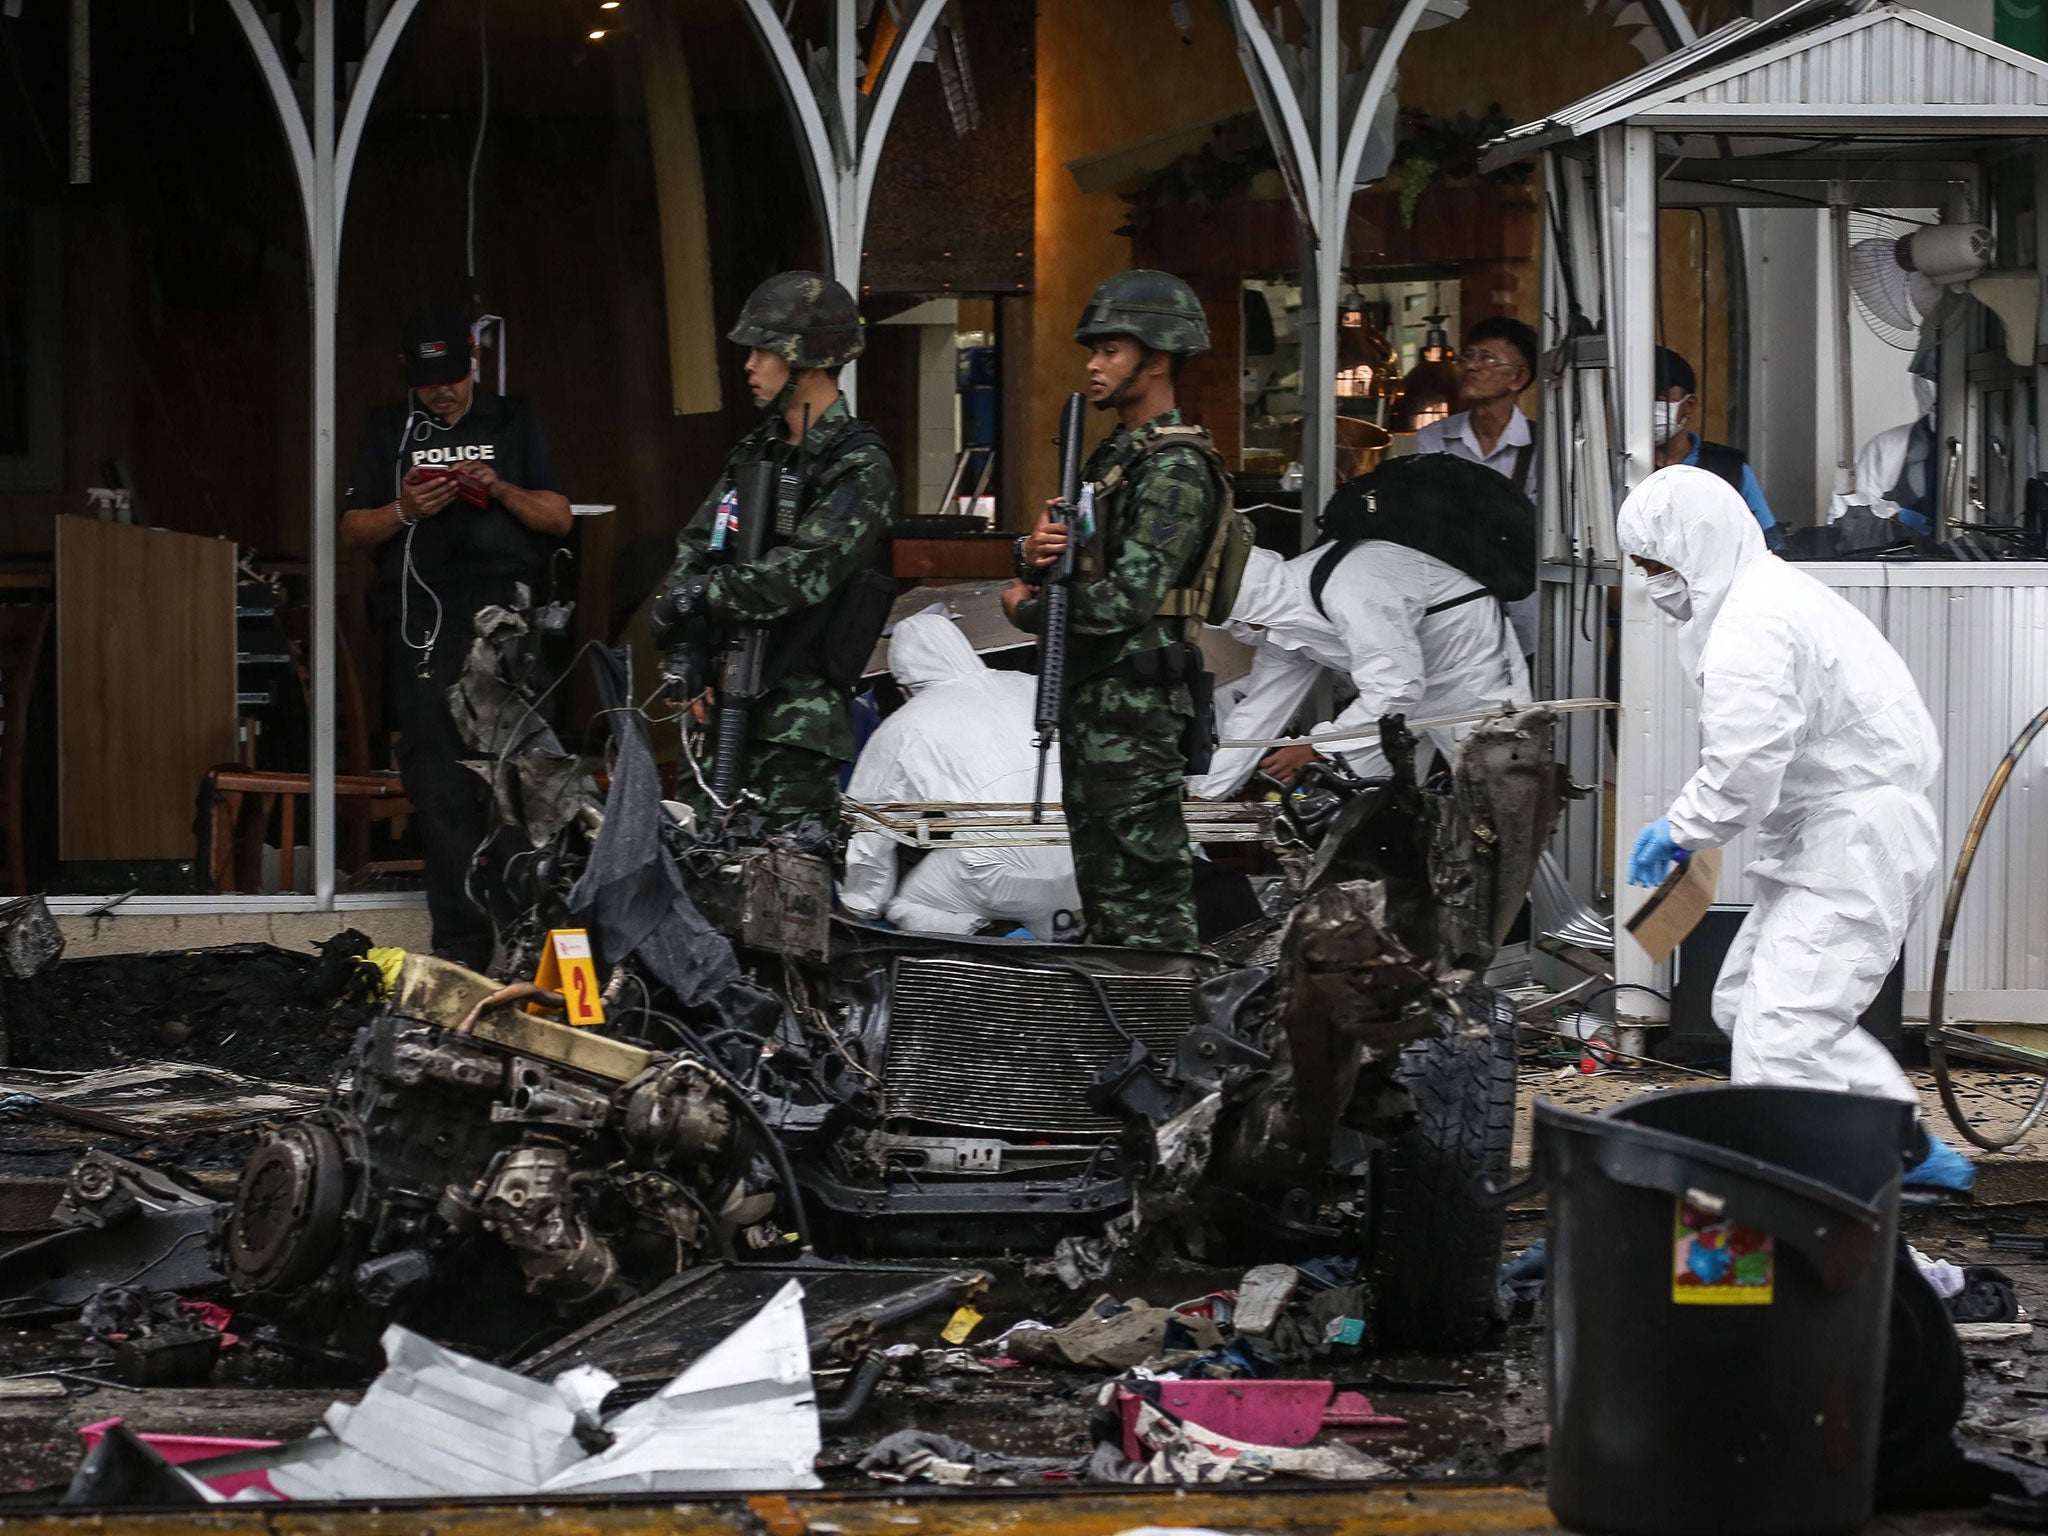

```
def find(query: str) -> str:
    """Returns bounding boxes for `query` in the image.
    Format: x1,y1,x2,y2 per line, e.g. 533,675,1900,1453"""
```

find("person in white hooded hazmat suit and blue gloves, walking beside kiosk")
1618,465,1974,1188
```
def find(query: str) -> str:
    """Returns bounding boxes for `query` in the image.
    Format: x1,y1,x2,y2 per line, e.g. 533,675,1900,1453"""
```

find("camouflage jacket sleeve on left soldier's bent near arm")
704,449,897,625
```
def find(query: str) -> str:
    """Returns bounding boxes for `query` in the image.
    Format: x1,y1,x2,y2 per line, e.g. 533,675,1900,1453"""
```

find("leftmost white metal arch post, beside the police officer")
227,0,420,911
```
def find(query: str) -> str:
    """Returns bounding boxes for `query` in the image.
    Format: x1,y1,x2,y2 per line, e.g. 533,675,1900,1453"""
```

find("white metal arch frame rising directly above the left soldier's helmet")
743,0,946,403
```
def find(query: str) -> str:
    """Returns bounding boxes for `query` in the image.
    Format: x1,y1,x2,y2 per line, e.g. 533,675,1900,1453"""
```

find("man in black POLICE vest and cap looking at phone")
340,309,571,971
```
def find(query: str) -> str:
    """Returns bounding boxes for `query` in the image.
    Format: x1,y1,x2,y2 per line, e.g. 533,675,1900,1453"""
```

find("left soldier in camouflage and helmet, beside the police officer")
655,272,897,836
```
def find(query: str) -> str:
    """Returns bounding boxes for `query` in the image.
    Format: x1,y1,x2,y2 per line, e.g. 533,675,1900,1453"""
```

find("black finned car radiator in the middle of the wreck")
887,956,1194,1137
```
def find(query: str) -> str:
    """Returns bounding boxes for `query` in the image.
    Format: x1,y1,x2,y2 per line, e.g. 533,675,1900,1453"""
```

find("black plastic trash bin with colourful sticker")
1534,1087,1913,1536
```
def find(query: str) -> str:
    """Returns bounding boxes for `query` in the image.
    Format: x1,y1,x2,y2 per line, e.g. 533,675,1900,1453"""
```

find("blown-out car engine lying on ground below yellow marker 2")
221,956,776,1358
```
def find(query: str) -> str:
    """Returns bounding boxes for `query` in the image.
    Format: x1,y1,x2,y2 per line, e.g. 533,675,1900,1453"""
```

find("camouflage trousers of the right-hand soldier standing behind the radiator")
1059,678,1200,950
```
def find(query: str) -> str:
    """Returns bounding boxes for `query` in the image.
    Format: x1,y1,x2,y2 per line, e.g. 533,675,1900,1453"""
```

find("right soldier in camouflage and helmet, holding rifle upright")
1004,270,1225,950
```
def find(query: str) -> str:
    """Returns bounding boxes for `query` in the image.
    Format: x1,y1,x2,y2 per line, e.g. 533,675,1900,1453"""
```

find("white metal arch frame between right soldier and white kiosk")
1212,0,1694,541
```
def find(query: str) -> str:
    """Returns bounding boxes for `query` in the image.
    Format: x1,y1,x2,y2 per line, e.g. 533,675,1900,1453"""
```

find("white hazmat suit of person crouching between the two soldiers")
840,612,1081,938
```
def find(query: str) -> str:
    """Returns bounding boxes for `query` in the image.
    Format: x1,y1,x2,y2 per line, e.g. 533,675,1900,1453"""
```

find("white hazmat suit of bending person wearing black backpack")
1190,539,1530,801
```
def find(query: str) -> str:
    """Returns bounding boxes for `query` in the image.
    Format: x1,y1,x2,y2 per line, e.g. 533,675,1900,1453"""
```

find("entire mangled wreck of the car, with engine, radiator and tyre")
199,610,1567,1360
